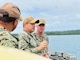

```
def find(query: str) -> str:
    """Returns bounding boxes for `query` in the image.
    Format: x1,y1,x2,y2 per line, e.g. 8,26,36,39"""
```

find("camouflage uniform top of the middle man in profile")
19,31,39,54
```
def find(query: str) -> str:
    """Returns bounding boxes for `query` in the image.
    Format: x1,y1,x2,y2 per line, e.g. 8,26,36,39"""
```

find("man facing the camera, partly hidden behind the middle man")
34,19,49,57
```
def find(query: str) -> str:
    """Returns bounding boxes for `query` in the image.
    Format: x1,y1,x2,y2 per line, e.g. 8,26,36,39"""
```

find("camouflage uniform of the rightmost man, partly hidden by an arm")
34,33,49,55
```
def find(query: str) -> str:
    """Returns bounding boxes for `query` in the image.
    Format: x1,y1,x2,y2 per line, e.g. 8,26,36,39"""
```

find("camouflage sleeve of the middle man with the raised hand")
19,34,38,53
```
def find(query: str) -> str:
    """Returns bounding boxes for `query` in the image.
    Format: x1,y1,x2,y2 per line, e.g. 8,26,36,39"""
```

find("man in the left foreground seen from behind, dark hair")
0,3,20,48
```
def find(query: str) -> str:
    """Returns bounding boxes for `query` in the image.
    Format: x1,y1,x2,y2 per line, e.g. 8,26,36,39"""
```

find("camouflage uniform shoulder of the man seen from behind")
0,26,18,48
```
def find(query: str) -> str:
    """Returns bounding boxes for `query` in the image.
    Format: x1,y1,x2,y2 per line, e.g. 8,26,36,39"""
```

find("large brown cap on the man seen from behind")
0,3,21,19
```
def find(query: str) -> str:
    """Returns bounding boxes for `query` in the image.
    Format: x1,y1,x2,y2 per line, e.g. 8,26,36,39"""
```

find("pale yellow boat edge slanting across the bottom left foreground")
0,46,51,60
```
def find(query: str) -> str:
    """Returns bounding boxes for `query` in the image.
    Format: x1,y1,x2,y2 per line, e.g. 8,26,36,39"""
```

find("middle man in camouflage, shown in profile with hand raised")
19,16,47,55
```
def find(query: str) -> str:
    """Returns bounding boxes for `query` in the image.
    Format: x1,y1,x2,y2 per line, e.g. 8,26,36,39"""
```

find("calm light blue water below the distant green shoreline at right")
48,35,80,60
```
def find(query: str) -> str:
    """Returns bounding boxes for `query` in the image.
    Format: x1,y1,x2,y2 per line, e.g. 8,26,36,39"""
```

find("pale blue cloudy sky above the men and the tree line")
0,0,80,33
